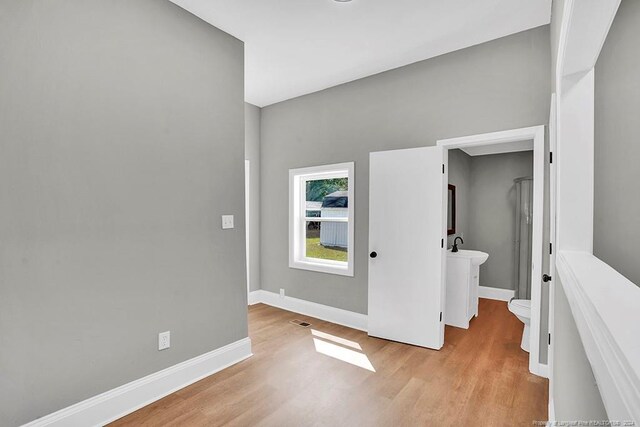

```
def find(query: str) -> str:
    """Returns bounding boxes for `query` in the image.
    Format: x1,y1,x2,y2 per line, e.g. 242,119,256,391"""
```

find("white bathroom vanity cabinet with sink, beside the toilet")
444,250,489,329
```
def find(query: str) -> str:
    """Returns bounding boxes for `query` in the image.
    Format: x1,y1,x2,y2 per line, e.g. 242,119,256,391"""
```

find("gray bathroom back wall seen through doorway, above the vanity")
465,151,533,289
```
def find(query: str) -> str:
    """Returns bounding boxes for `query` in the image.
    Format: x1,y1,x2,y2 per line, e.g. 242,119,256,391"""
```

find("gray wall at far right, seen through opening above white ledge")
594,0,640,286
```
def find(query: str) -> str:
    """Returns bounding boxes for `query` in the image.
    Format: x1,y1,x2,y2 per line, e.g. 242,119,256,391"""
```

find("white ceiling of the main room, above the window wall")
171,0,551,107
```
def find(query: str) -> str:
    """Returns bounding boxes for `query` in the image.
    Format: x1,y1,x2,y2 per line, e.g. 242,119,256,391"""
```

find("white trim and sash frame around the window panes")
289,162,355,277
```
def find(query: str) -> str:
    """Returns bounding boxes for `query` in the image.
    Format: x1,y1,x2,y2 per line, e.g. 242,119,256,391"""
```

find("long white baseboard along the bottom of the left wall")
23,338,251,427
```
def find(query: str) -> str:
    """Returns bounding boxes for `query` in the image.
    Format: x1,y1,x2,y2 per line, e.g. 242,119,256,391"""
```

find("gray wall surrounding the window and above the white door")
261,26,551,313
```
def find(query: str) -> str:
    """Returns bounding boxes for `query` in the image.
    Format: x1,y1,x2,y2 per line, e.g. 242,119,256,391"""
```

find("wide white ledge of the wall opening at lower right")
556,251,640,423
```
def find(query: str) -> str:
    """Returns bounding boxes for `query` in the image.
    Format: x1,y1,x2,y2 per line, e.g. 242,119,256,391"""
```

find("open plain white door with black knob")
368,147,447,349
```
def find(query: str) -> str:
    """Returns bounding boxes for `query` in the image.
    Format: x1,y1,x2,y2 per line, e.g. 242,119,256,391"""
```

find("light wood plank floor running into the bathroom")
113,299,548,427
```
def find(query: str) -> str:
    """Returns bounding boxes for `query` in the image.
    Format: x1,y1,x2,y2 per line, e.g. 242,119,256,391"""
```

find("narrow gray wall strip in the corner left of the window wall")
244,104,262,291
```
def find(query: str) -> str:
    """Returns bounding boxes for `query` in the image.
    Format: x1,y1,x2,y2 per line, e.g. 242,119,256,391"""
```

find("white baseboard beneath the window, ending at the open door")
249,289,368,332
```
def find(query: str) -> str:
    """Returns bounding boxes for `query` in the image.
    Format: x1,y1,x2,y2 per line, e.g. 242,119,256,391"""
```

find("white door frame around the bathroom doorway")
436,125,548,378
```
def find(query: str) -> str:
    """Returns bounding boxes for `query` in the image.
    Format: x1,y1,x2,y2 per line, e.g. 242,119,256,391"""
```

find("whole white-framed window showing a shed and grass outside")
289,163,354,276
